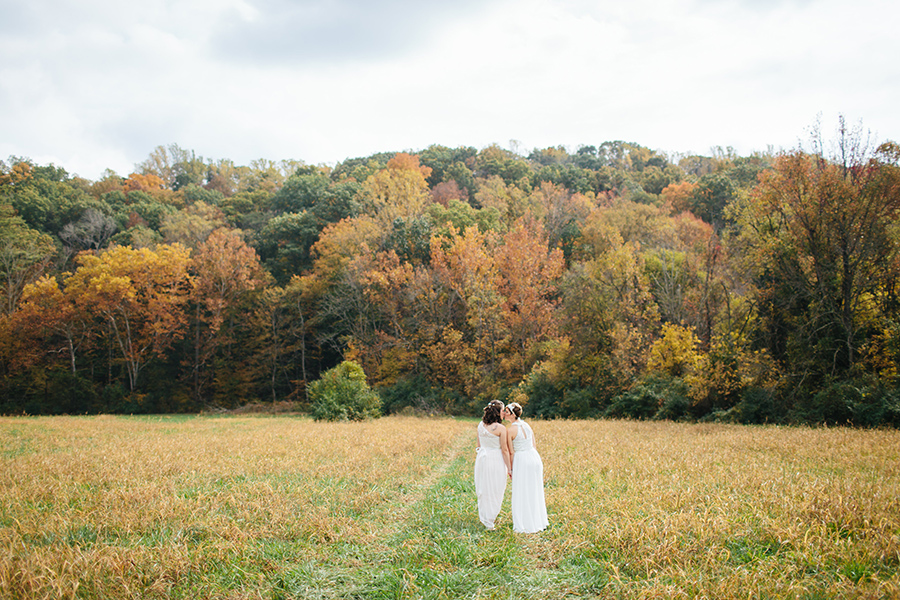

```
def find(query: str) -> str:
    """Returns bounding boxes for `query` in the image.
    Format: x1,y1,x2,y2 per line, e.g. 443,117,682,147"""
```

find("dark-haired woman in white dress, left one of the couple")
475,400,511,529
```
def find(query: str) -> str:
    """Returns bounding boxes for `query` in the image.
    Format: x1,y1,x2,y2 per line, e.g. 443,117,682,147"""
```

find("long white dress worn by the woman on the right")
510,420,550,533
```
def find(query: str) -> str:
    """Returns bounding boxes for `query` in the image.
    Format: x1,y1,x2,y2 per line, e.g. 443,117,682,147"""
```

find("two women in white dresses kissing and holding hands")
475,400,548,533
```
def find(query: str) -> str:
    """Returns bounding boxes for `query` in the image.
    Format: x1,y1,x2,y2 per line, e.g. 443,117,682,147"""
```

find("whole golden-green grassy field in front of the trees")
0,416,900,598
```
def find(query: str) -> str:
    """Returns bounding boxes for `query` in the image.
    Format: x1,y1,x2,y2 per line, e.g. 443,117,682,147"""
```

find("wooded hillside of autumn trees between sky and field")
0,122,900,426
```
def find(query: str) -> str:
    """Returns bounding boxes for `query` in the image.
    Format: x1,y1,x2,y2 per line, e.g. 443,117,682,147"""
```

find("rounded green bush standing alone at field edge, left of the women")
309,361,381,421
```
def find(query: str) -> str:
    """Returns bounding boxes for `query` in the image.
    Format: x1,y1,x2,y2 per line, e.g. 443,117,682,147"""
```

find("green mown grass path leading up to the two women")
253,432,572,599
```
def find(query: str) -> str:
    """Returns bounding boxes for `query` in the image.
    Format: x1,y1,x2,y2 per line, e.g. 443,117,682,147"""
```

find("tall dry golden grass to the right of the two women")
535,421,900,598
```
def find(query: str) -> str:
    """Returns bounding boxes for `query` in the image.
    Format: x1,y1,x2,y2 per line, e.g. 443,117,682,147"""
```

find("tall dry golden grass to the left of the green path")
0,416,474,598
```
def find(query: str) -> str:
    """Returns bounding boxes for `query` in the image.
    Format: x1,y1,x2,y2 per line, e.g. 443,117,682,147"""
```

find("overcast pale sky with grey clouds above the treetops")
0,0,900,179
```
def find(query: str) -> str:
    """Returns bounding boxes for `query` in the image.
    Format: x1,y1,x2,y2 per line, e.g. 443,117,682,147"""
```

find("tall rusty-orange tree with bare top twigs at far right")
735,121,900,376
